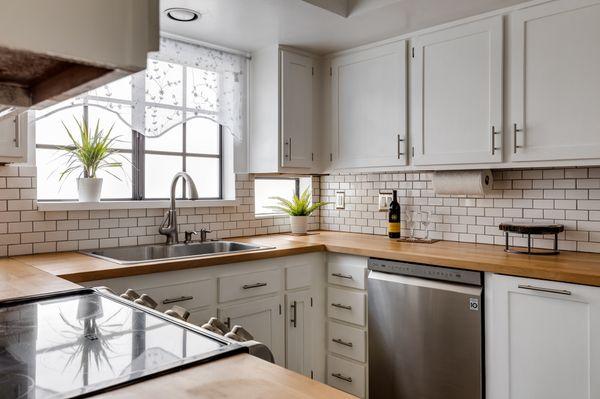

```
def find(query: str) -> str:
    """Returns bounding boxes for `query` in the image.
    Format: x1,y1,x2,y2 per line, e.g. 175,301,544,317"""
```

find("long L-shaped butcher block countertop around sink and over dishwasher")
12,231,600,286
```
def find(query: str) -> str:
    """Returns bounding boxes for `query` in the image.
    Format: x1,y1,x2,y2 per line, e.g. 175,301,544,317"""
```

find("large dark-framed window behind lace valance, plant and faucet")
35,69,223,201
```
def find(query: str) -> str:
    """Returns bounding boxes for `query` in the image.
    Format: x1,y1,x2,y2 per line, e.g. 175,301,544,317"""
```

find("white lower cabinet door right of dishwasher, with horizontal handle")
485,275,600,399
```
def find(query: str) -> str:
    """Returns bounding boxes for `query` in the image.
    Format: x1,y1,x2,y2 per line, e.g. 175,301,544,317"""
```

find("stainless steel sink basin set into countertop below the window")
81,241,272,264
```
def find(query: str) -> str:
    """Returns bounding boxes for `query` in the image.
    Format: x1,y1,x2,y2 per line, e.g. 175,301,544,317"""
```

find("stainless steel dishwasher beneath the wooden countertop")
368,258,483,399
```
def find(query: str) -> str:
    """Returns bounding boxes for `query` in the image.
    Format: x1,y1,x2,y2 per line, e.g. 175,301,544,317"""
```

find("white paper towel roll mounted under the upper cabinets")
432,169,494,195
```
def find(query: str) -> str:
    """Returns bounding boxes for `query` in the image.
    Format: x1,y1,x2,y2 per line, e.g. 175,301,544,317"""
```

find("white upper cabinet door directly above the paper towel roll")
411,16,503,165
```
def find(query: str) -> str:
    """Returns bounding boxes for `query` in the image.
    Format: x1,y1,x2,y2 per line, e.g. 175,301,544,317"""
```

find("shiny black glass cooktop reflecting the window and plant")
0,290,244,399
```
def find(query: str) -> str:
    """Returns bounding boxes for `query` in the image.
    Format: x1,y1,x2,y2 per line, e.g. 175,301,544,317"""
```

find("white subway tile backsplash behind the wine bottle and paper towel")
320,168,600,252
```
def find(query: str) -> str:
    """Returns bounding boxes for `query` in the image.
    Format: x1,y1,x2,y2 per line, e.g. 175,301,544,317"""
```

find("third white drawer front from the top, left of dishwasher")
327,321,367,362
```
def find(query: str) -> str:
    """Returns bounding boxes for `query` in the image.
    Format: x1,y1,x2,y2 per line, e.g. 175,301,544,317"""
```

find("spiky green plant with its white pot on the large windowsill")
59,118,122,202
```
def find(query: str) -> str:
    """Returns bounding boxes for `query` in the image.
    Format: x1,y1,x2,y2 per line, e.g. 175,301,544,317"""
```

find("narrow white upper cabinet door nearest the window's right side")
280,51,314,168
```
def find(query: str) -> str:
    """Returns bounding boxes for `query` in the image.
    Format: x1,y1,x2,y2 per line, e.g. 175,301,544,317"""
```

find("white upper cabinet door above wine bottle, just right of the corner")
331,41,407,169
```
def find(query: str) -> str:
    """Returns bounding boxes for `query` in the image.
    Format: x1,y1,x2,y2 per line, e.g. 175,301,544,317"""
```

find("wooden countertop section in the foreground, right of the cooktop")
95,354,355,399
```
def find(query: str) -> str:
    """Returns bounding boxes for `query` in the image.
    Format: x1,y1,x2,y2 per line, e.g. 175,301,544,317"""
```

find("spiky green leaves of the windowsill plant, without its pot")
59,118,123,180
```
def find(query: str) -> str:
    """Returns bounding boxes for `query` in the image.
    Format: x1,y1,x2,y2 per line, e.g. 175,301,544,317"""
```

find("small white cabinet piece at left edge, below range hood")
0,113,28,164
